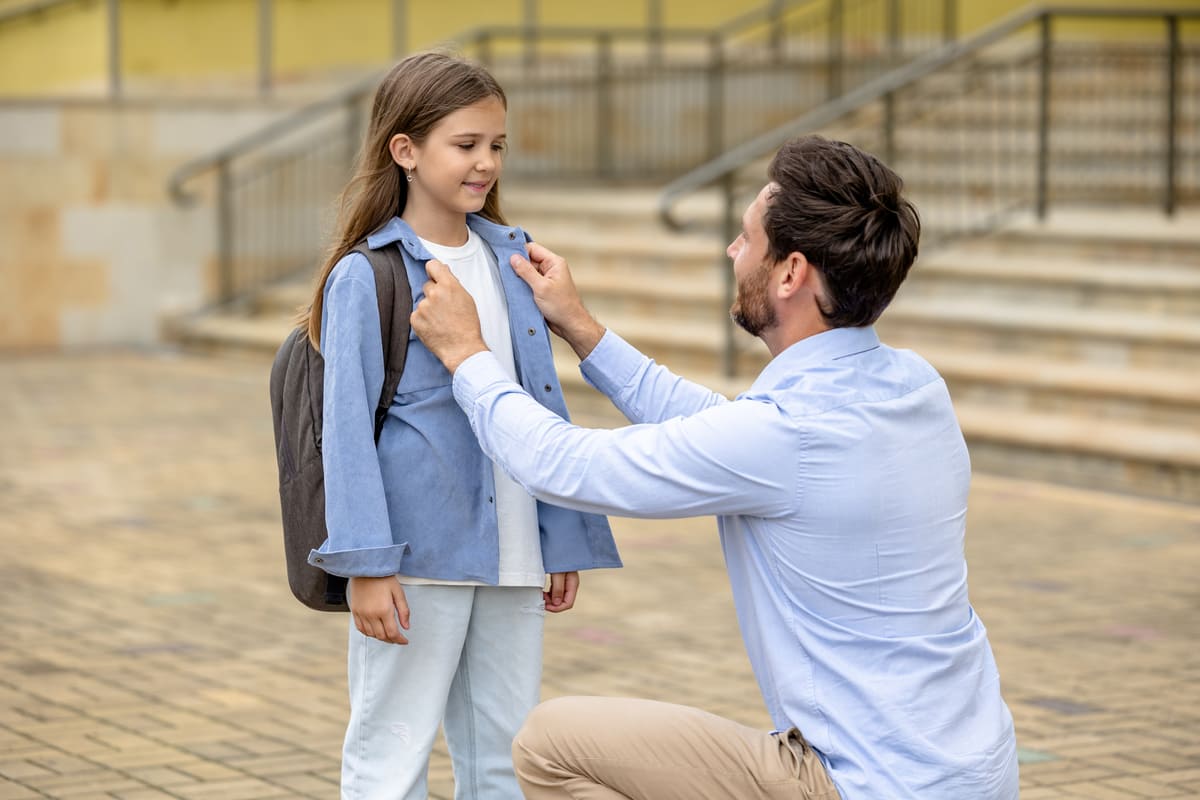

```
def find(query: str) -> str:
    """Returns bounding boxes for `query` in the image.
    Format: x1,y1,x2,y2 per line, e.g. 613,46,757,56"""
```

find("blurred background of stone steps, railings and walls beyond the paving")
7,0,1200,500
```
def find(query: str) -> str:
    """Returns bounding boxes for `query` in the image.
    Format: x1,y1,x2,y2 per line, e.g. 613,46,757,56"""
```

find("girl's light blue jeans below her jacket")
342,585,545,800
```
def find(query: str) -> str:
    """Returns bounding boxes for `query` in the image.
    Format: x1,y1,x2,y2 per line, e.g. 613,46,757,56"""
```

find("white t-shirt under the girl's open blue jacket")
400,230,546,587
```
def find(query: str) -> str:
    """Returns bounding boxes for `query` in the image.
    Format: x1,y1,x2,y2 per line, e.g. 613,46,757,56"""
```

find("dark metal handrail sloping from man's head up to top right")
659,5,1200,230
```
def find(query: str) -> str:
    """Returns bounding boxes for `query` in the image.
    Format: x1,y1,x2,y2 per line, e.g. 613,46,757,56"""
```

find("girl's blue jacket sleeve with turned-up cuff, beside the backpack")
308,260,407,577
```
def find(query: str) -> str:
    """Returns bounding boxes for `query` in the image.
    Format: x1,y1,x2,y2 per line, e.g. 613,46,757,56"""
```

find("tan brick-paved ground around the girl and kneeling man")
0,353,1200,800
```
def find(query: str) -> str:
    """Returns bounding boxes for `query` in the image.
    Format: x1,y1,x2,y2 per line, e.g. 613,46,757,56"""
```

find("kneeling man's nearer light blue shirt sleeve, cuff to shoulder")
454,353,798,518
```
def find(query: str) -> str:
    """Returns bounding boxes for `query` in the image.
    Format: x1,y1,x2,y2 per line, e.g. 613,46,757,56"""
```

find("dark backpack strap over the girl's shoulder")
354,240,413,444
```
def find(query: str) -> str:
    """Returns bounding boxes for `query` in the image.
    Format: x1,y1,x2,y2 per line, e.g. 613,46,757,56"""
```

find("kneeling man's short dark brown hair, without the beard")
763,136,920,327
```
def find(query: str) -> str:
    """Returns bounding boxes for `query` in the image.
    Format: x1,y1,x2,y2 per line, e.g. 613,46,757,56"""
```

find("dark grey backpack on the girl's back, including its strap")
270,240,413,612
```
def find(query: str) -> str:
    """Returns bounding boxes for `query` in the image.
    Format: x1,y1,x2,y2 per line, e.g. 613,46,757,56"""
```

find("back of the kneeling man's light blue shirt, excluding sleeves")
720,329,1016,800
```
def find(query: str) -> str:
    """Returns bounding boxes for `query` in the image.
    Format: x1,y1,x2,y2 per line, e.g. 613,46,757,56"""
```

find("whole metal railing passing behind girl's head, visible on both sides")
169,0,953,303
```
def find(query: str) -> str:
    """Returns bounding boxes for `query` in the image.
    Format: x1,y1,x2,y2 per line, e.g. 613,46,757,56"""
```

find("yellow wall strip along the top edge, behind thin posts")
0,0,1200,96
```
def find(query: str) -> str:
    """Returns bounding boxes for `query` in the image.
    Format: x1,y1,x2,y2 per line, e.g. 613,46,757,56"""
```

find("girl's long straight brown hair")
296,53,508,349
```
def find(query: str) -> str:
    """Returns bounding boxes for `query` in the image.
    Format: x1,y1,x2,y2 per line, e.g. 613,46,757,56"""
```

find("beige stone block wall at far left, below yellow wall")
0,103,286,350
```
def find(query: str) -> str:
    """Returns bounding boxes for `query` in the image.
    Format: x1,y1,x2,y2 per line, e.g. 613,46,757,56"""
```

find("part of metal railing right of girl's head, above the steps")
461,0,956,181
